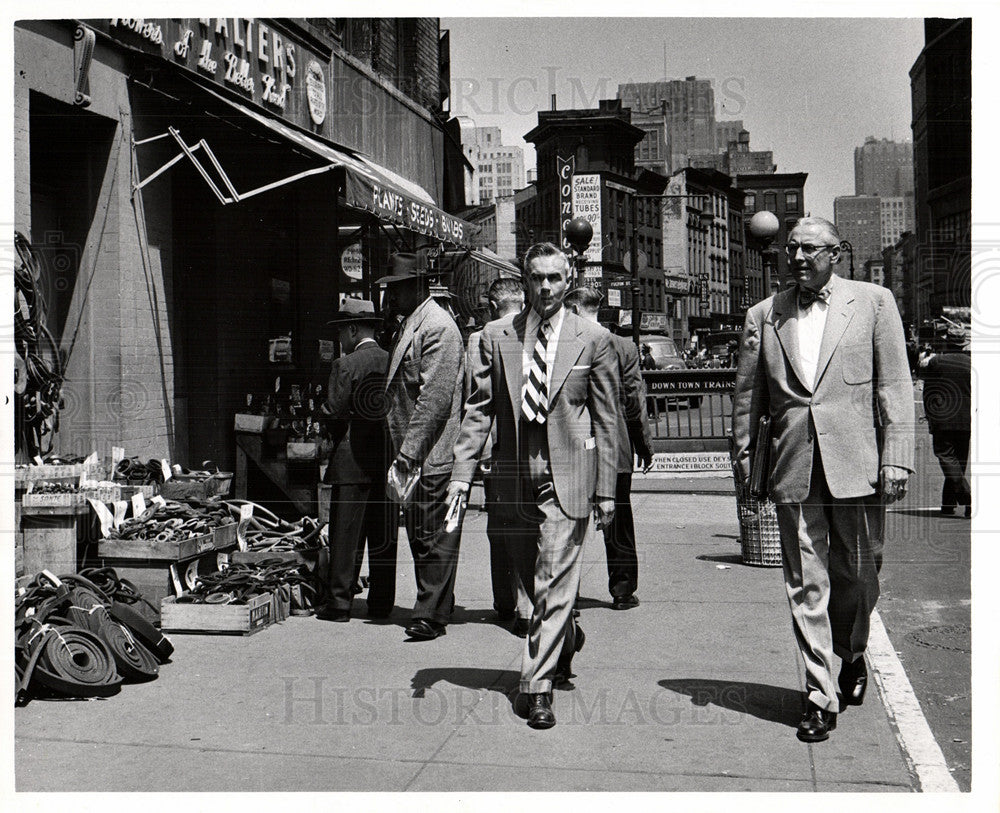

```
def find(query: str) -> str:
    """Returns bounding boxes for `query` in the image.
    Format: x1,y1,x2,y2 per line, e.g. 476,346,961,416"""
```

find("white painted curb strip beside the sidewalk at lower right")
868,610,961,793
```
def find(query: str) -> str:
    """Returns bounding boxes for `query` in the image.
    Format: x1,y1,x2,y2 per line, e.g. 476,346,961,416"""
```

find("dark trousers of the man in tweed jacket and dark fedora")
403,471,462,624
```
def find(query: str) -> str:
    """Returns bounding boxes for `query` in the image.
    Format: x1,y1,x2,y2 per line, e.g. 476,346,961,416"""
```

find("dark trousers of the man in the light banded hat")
327,482,397,615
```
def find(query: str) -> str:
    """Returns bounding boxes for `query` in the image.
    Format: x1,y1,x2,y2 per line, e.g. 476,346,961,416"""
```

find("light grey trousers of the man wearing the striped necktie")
509,422,587,694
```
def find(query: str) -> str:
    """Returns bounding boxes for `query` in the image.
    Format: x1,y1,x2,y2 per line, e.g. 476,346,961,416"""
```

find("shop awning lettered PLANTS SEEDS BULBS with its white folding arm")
136,85,477,247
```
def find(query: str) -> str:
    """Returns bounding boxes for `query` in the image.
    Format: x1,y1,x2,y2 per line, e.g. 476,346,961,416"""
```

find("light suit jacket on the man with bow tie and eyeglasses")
733,276,914,503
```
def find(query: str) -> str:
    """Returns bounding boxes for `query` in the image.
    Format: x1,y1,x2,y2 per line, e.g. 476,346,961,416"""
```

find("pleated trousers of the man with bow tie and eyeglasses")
776,447,885,712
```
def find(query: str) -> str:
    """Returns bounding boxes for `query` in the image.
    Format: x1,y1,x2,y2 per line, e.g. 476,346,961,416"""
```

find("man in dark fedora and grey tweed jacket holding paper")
378,254,464,641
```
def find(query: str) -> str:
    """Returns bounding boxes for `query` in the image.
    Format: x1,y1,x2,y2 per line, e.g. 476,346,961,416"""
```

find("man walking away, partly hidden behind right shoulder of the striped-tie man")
566,288,653,610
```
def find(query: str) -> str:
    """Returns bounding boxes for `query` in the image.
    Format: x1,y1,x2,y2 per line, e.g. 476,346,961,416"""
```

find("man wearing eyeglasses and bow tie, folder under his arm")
733,218,914,742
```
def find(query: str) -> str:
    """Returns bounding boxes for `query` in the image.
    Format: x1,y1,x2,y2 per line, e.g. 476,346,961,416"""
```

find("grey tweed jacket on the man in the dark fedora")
385,297,464,474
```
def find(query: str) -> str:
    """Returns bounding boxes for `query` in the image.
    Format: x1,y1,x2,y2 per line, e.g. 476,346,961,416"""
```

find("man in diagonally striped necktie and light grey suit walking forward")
448,243,619,728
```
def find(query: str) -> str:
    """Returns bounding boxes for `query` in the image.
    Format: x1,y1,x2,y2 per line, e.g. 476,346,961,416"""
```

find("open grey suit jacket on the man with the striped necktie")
452,310,618,519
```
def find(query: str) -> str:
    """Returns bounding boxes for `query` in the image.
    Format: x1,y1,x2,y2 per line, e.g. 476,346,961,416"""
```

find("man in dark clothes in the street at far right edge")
920,340,972,517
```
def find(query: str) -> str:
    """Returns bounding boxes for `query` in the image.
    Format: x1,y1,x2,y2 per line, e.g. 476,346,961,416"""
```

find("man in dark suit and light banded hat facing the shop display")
316,299,396,621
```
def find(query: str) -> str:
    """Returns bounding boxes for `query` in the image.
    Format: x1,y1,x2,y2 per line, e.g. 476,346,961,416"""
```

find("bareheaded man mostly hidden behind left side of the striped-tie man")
465,278,531,638
